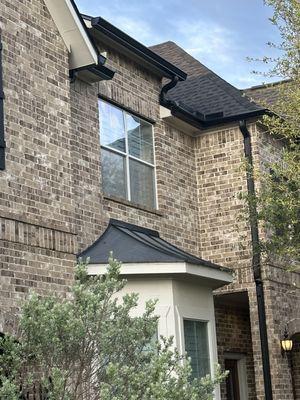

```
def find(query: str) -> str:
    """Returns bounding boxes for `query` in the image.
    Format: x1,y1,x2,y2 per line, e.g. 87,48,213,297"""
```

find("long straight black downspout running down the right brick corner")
239,120,273,400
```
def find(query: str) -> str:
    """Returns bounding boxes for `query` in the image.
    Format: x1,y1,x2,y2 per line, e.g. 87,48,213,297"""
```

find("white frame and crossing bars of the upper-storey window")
98,98,158,210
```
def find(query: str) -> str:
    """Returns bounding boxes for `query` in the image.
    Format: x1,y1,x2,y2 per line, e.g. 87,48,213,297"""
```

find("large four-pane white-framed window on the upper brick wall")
99,99,157,208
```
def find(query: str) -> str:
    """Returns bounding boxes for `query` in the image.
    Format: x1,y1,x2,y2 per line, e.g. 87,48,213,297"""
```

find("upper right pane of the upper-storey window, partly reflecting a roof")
126,114,153,163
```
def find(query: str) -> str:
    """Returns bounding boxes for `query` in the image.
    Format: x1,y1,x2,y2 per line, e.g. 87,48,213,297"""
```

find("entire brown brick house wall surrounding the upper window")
0,4,299,400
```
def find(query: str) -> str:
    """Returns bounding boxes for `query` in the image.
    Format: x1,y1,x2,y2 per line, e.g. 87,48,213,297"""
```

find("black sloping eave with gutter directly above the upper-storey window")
83,15,187,81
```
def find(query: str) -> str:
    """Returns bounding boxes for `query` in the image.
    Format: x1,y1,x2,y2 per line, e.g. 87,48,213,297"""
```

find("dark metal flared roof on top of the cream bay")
78,219,224,270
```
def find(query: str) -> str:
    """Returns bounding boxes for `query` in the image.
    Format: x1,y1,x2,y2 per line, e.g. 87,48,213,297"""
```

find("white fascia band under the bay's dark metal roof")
88,262,232,284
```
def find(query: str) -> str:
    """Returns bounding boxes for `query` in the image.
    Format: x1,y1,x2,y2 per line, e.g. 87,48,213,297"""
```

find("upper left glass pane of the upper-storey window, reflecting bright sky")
99,100,126,152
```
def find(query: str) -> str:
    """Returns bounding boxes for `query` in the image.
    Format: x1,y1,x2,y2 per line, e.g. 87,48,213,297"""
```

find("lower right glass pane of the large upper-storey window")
129,159,155,208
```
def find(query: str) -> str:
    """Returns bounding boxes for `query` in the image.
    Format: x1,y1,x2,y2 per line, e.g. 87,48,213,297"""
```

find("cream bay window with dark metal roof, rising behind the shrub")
80,220,232,400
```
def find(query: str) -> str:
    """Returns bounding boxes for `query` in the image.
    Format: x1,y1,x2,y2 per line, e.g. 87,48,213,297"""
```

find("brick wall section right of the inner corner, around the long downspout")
196,124,300,400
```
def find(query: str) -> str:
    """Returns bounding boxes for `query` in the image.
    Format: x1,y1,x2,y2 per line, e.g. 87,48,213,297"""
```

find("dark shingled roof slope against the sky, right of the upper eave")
151,42,266,126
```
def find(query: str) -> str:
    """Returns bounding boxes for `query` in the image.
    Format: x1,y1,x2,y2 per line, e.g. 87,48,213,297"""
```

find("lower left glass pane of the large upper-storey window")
101,149,127,199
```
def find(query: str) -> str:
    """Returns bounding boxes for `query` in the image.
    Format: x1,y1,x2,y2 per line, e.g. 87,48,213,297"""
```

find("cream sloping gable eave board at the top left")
44,0,98,69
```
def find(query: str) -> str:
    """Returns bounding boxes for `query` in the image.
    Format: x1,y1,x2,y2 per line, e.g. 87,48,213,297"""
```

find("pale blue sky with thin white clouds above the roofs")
76,0,272,87
